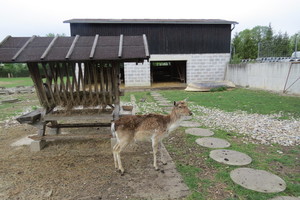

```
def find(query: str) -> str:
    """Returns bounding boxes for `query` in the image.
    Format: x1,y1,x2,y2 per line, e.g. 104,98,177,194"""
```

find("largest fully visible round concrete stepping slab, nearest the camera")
230,168,286,193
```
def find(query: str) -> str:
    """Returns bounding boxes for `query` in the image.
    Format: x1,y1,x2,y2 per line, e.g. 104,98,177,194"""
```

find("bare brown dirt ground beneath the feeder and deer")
0,124,189,200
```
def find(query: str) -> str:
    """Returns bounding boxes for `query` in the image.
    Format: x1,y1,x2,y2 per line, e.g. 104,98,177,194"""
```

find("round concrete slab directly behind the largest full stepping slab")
209,149,252,166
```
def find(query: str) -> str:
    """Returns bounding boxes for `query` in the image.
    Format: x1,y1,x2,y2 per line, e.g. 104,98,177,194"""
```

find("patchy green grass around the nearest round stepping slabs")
166,130,300,200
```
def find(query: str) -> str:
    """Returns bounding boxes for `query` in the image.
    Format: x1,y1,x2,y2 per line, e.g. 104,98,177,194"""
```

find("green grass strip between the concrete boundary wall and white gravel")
160,89,300,119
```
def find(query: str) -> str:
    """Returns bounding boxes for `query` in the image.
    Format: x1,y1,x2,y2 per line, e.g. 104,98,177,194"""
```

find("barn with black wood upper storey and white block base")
64,19,237,87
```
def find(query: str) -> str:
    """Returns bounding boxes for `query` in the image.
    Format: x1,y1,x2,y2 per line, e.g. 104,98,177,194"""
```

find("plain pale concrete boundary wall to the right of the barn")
226,62,300,94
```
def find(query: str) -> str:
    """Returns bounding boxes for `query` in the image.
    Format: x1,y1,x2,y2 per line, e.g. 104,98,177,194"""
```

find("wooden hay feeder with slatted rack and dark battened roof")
0,35,149,141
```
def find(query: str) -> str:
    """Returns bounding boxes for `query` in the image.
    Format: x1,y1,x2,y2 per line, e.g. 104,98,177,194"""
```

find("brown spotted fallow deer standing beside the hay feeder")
111,101,192,175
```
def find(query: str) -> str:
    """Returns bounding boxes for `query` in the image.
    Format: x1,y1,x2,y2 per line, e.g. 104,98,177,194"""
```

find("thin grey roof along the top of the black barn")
64,19,238,24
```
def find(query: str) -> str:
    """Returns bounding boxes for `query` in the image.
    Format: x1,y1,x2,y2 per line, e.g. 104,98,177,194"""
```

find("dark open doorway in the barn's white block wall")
150,61,186,83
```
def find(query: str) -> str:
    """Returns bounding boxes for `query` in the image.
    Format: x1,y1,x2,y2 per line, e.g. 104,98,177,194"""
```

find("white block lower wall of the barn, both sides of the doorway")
124,53,230,87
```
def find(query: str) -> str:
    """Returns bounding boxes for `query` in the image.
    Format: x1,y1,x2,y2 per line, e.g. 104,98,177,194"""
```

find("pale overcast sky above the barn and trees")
0,0,300,41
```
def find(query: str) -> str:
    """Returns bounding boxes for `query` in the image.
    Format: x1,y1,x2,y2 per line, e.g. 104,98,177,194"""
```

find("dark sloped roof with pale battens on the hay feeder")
0,35,150,63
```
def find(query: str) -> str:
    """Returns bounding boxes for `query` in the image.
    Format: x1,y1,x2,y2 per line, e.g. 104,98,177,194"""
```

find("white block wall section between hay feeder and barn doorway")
124,61,151,87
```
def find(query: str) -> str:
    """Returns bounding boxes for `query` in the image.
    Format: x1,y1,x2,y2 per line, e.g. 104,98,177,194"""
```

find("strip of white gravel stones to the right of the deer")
190,104,300,146
